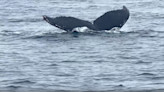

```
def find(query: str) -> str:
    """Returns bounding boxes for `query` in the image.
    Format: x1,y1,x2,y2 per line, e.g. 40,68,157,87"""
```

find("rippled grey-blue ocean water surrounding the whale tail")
0,0,164,92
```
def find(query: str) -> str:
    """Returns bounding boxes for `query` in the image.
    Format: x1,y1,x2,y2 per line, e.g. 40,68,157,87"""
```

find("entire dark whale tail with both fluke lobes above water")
43,6,130,31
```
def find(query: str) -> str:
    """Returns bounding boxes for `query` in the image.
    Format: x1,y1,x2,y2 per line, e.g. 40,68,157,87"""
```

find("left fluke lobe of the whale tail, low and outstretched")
43,16,96,31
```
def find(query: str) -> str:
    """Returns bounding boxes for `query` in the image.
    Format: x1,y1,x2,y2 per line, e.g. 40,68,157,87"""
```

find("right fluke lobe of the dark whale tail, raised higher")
93,6,130,30
